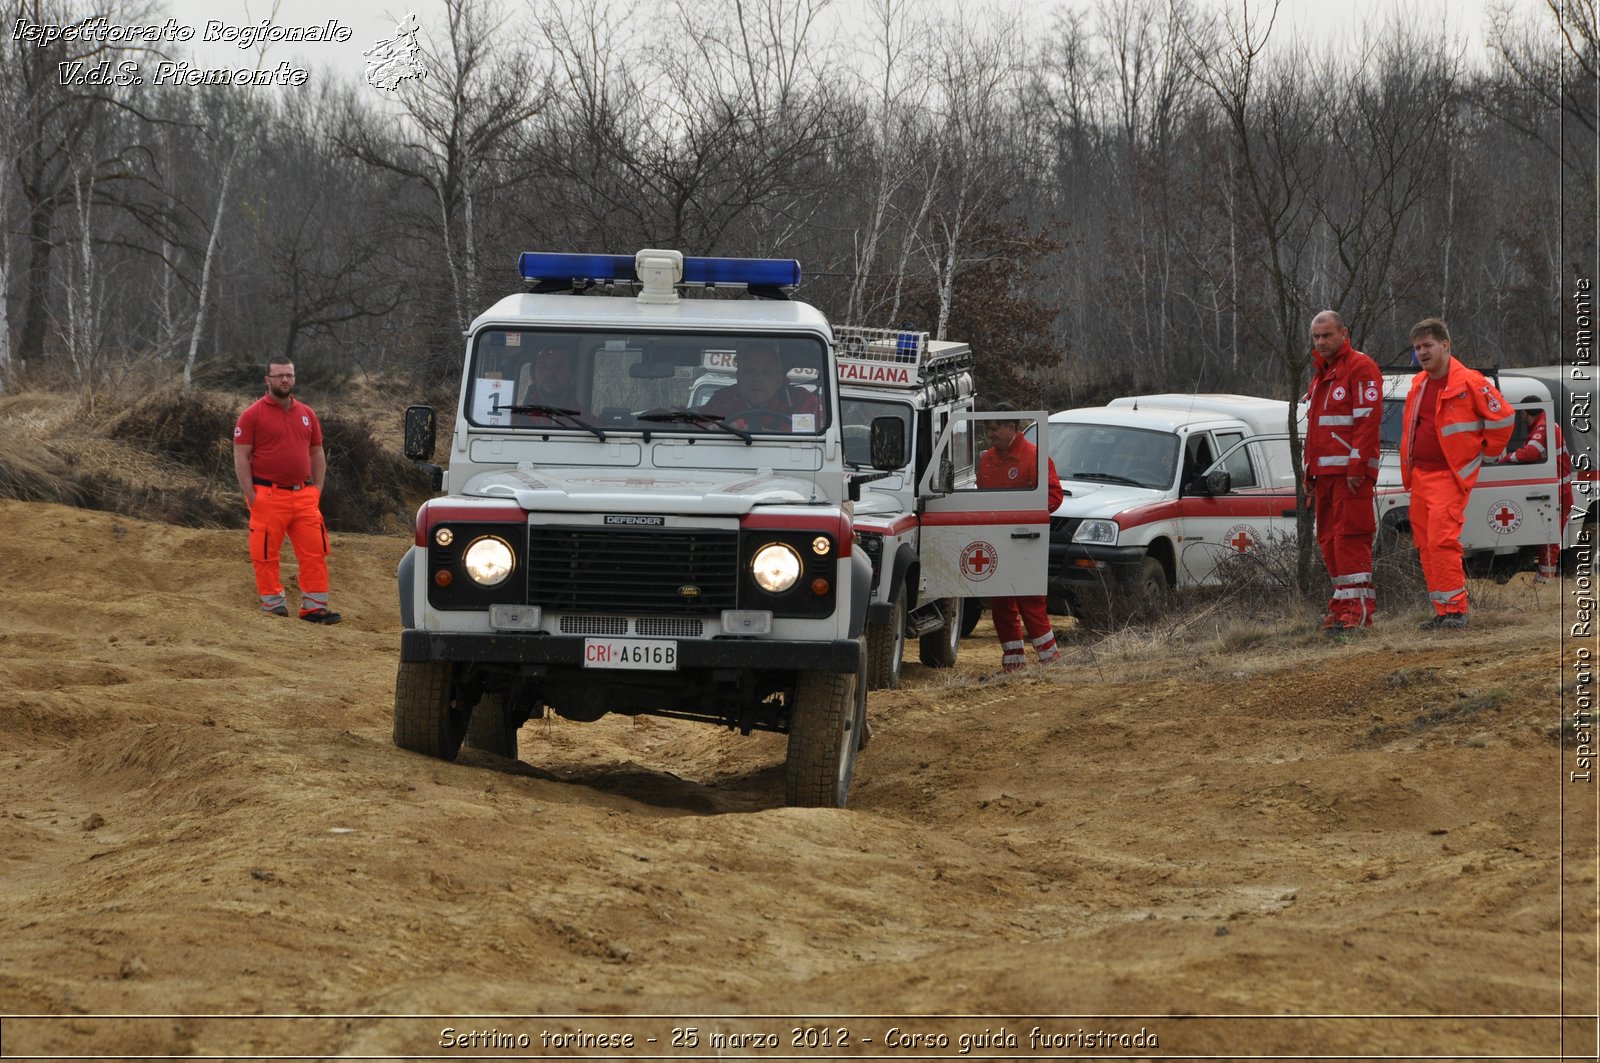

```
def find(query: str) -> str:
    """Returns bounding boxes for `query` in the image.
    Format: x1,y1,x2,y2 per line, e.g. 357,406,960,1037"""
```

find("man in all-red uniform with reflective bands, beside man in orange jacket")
1306,311,1384,634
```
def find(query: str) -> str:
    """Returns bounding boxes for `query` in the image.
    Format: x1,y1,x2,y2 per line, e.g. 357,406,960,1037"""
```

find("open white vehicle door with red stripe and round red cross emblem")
918,410,1050,599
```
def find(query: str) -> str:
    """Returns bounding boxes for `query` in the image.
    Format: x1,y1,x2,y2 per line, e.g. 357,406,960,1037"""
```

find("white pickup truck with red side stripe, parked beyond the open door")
1048,394,1294,626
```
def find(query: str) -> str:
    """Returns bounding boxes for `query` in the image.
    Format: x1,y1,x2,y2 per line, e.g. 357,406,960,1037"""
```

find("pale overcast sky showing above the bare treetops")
140,0,1544,93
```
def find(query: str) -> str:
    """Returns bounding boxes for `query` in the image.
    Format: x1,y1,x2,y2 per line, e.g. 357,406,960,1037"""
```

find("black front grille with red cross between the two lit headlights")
528,525,739,616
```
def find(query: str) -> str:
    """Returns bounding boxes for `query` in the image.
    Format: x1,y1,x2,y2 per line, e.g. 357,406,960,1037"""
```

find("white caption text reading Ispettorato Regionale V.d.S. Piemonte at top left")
11,16,352,86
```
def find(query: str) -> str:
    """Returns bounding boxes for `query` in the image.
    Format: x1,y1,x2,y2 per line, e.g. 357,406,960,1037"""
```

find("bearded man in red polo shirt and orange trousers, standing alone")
234,359,341,624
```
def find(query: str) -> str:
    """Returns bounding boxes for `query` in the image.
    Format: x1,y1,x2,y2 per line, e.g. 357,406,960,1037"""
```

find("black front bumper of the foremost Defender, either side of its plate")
400,629,861,674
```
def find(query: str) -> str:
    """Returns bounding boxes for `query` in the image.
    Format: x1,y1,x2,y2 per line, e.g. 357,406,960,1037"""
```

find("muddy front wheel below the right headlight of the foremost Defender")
784,647,867,808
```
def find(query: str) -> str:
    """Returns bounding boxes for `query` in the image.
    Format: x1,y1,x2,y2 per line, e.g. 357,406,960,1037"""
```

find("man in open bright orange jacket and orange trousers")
1400,317,1517,629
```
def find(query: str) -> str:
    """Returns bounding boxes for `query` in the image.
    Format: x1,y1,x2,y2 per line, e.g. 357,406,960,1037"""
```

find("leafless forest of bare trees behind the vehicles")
0,0,1597,407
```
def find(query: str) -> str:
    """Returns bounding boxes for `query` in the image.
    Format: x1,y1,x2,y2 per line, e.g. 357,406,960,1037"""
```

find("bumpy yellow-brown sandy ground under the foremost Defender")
0,503,1595,1058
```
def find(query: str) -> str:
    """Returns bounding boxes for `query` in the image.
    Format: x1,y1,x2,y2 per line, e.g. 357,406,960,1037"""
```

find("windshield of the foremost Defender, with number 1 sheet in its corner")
466,328,830,437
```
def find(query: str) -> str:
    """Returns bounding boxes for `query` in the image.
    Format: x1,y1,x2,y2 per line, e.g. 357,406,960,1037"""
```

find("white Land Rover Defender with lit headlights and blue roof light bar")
394,250,872,807
